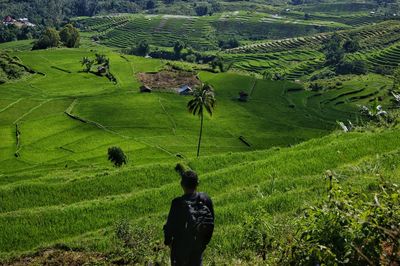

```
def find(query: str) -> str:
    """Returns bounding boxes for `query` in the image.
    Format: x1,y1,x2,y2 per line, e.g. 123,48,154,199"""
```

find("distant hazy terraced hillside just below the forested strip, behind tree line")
76,12,345,50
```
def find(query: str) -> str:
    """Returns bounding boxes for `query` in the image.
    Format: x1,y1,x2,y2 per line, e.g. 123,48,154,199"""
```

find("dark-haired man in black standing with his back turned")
164,170,214,266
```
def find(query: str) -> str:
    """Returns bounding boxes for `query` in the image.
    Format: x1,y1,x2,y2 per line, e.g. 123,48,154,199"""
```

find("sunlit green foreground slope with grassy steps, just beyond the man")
0,127,400,262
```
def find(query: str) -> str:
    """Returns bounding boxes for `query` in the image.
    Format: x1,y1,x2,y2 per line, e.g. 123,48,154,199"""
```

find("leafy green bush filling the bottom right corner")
280,181,400,265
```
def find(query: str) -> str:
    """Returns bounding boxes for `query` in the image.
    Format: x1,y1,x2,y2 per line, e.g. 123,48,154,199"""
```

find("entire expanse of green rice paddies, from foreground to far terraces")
0,0,400,265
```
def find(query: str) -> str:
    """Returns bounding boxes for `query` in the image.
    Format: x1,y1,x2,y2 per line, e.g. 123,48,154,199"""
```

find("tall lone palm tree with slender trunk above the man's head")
187,84,215,157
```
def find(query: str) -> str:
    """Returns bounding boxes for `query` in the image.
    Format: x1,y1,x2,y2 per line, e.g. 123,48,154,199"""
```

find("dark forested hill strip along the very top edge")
0,0,399,25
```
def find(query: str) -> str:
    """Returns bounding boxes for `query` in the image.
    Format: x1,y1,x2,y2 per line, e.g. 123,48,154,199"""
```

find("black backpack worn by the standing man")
183,193,214,245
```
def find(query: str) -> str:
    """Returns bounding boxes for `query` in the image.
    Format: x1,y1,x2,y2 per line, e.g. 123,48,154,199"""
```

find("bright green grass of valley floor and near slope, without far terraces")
0,43,400,261
